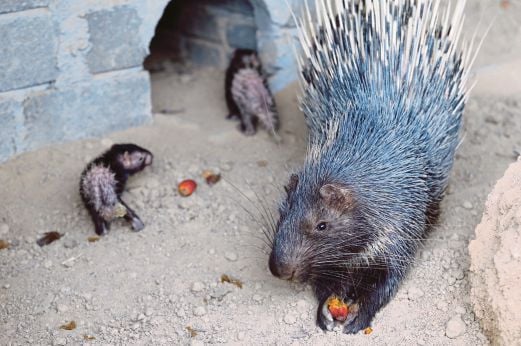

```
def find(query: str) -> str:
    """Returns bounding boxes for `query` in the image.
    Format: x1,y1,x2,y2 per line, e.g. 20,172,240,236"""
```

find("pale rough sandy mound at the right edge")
469,160,521,345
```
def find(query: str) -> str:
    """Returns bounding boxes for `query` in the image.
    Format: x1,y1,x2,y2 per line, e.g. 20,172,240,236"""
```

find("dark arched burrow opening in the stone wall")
144,0,257,72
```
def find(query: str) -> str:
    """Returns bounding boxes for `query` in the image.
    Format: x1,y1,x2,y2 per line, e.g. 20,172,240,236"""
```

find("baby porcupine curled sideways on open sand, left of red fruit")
80,144,153,235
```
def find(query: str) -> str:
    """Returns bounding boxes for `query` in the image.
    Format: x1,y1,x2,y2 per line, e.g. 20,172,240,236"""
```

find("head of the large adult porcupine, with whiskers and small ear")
269,173,375,283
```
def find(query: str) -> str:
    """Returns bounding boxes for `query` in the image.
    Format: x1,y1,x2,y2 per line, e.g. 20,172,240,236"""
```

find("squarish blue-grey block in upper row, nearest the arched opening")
86,6,147,73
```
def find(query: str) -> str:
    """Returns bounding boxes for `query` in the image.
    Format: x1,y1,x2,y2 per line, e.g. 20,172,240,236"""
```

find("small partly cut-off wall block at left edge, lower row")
0,100,22,162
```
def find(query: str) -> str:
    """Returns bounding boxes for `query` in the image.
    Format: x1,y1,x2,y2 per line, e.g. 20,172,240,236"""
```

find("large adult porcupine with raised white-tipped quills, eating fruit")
269,0,471,333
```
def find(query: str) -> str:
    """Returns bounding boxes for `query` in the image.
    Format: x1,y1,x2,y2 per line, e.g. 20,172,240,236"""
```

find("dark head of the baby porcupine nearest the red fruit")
109,144,154,174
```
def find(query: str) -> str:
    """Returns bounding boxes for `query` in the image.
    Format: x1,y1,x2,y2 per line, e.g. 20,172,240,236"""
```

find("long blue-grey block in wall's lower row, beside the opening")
24,72,151,149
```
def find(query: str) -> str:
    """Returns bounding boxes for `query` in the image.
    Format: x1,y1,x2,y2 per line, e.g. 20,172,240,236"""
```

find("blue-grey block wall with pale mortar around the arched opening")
0,0,298,162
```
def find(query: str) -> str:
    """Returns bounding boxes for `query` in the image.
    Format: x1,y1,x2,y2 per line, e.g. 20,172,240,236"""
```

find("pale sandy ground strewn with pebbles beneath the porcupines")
0,1,521,345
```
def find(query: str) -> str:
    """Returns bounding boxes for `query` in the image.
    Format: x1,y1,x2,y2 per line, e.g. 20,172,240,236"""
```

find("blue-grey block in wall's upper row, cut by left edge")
0,14,58,92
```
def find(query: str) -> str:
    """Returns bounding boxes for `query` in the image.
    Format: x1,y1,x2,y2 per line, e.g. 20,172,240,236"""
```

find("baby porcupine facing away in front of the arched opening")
224,49,279,136
